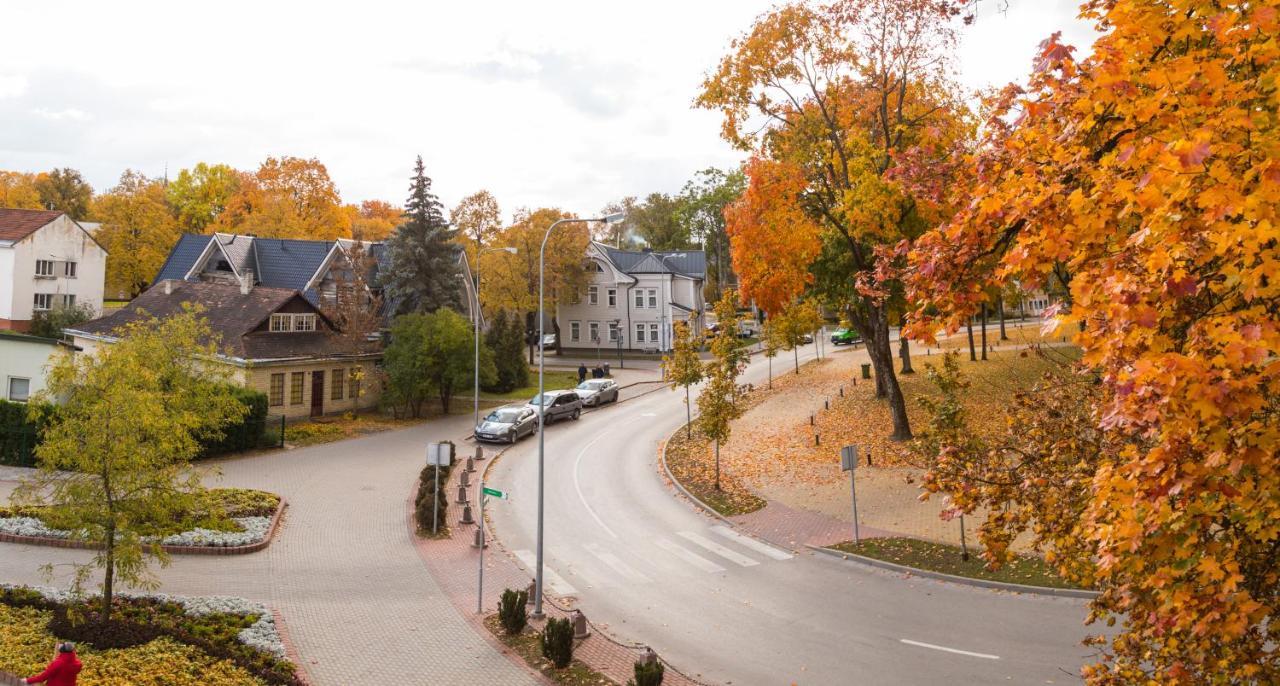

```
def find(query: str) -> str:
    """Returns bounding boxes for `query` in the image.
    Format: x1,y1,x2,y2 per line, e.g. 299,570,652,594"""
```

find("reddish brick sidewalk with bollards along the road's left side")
406,443,699,686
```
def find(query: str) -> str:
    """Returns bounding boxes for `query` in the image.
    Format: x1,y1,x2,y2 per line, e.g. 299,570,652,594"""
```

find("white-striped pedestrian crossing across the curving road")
515,526,795,595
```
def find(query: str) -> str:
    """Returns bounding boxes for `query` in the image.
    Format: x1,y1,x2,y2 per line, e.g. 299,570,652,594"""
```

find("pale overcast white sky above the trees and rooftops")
0,0,1093,216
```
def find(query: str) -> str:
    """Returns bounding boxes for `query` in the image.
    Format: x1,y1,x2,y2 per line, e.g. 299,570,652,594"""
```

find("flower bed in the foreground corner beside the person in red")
0,584,303,686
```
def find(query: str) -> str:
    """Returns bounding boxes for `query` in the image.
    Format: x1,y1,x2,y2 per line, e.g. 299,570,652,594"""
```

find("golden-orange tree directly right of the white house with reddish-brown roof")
93,169,180,297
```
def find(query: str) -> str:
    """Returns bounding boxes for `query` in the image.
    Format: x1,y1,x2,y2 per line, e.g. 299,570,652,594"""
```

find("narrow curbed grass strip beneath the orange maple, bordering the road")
829,538,1079,589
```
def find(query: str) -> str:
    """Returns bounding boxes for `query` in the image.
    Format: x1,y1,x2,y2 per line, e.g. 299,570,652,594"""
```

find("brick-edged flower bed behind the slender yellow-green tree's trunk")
0,489,283,553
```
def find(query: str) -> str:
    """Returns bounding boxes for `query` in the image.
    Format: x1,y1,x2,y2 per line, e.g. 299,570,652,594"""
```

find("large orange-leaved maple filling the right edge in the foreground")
910,0,1280,685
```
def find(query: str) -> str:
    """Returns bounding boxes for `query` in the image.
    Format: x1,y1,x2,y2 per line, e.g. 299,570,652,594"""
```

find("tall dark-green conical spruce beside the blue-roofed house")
383,156,462,314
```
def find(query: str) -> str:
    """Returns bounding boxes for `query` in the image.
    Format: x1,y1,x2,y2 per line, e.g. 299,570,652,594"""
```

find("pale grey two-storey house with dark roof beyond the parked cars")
556,241,707,352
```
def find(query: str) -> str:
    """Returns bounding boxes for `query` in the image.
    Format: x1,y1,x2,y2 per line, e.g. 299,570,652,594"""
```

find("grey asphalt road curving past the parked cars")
488,337,1092,686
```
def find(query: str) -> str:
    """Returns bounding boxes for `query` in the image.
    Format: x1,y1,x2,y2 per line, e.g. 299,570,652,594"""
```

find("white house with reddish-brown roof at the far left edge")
0,207,106,331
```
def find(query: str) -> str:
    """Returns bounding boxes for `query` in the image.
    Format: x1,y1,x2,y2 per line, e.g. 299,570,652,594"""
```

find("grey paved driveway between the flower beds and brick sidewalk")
0,413,538,685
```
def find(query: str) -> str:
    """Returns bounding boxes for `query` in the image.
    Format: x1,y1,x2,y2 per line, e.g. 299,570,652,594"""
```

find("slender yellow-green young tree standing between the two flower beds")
14,308,247,623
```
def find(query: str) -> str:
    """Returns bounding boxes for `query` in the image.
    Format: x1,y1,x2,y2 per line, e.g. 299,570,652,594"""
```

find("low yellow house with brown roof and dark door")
67,275,381,417
